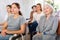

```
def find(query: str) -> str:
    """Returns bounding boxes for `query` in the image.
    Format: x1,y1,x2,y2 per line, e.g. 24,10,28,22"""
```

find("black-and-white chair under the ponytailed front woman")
9,18,29,40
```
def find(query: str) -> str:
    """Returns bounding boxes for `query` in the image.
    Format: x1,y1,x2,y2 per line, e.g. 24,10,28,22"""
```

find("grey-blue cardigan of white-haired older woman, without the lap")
36,15,58,34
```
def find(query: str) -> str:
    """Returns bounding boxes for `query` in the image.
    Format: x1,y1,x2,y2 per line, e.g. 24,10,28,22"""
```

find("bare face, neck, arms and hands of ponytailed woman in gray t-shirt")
1,4,26,36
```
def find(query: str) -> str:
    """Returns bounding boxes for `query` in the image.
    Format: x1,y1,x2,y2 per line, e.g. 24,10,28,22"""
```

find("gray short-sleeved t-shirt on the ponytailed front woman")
7,16,26,30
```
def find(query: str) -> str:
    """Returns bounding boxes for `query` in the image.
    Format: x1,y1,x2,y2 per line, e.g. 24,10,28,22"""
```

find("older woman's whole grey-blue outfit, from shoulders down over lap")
33,15,58,40
